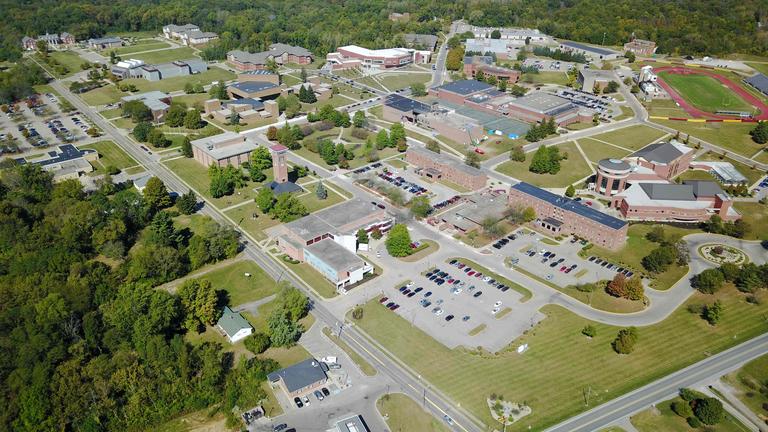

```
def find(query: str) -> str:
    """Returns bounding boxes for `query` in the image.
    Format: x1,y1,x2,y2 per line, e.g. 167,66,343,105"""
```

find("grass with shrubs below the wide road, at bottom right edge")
630,397,750,432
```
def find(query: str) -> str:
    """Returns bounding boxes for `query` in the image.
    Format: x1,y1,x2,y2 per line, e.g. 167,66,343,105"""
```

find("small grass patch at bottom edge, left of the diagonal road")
376,393,448,432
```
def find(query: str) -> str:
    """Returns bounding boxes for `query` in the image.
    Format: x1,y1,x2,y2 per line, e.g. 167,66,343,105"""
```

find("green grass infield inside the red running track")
659,72,755,113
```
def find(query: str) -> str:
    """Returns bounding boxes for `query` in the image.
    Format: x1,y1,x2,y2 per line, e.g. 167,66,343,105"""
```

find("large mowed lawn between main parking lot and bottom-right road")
357,286,768,431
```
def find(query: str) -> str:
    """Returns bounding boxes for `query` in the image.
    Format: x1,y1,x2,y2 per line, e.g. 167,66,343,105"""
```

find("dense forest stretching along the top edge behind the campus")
0,0,768,60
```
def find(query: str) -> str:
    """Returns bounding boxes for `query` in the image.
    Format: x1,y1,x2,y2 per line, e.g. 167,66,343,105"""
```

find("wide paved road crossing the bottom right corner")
547,334,768,432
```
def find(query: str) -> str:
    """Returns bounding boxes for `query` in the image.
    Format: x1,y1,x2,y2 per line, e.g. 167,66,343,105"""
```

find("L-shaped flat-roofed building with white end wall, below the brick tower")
273,198,394,292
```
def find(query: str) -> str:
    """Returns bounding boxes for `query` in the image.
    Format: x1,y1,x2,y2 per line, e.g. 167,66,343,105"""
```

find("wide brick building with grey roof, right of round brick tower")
611,180,741,222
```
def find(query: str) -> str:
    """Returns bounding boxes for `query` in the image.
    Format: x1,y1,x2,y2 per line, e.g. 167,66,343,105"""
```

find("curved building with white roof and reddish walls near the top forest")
326,45,432,70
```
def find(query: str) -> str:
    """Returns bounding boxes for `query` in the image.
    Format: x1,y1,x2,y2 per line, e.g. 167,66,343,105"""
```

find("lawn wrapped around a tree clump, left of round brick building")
496,142,593,188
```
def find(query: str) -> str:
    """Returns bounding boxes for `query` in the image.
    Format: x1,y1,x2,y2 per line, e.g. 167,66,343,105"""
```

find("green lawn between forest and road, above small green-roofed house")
199,260,278,306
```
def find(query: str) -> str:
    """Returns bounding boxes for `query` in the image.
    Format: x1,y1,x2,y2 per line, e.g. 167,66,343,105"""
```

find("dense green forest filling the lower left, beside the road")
0,164,279,431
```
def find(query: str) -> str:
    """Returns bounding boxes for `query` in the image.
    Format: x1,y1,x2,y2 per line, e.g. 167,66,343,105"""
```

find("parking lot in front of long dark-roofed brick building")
491,231,634,287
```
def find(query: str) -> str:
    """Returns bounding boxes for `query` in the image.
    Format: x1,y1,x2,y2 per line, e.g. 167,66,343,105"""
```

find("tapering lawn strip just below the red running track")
653,120,763,157
